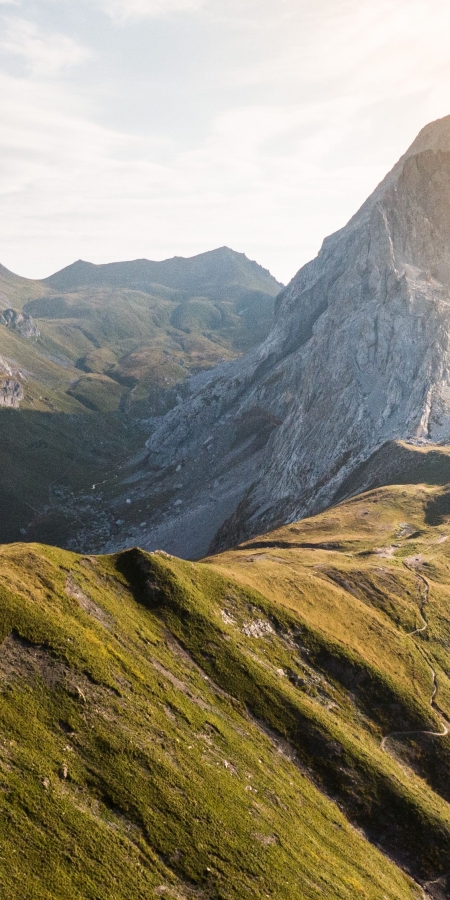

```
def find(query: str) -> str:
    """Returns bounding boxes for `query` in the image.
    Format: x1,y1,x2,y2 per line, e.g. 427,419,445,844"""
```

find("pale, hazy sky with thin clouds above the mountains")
0,0,450,282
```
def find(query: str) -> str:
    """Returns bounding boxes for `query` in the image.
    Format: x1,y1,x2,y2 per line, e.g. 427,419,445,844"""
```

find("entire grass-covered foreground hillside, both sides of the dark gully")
0,486,450,900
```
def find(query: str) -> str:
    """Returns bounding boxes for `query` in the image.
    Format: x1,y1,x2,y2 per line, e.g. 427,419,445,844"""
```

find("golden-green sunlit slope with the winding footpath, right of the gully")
208,486,450,896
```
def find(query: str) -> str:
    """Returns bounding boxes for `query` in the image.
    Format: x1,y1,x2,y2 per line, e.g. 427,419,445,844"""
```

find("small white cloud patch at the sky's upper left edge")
0,17,89,77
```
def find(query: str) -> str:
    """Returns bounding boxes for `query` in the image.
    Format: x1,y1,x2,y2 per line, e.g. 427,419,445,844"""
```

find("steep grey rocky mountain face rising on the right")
141,117,450,556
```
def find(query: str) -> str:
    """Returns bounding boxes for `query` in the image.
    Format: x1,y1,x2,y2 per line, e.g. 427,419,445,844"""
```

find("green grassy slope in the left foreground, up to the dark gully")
0,546,418,900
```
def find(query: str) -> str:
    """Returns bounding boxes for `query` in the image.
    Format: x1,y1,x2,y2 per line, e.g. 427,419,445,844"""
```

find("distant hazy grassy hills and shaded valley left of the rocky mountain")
0,248,281,546
